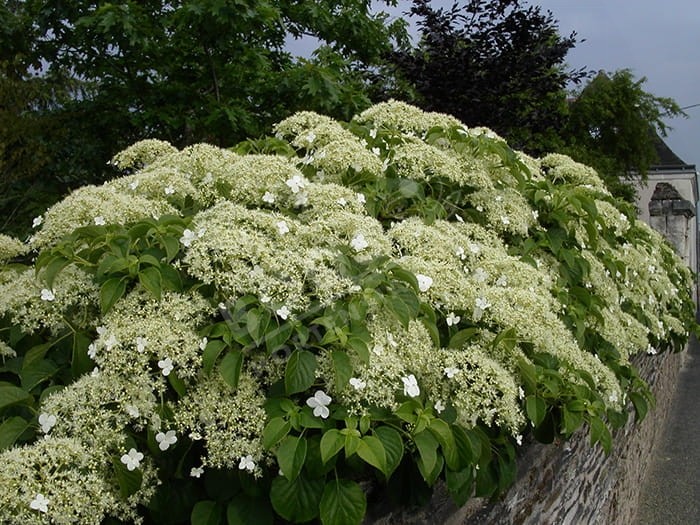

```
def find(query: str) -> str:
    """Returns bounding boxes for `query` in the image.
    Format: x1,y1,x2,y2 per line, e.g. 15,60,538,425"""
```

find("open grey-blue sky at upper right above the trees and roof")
529,0,700,167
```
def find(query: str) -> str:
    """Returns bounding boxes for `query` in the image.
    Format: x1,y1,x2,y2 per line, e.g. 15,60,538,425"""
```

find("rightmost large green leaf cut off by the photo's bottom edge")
320,479,367,525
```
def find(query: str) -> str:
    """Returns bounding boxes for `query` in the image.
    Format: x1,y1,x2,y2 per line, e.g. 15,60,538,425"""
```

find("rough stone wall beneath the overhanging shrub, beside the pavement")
366,346,686,525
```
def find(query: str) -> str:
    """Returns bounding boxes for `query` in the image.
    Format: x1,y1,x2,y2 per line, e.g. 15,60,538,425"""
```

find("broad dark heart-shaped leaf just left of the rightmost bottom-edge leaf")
270,474,324,523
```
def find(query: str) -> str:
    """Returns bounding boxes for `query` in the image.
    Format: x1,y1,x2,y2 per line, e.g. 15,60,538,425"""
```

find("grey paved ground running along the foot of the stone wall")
635,340,700,525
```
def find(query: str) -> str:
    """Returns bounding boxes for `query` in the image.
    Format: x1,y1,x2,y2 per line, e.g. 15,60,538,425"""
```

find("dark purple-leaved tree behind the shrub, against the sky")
382,0,585,153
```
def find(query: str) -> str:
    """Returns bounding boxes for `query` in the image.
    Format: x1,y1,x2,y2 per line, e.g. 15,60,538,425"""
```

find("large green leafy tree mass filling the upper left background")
0,0,406,234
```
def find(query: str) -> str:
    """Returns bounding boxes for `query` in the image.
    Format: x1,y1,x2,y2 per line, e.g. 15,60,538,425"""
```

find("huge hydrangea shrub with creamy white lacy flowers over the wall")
0,102,695,525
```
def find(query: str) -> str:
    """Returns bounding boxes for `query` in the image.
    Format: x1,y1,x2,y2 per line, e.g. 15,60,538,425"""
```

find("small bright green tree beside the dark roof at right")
562,69,685,200
